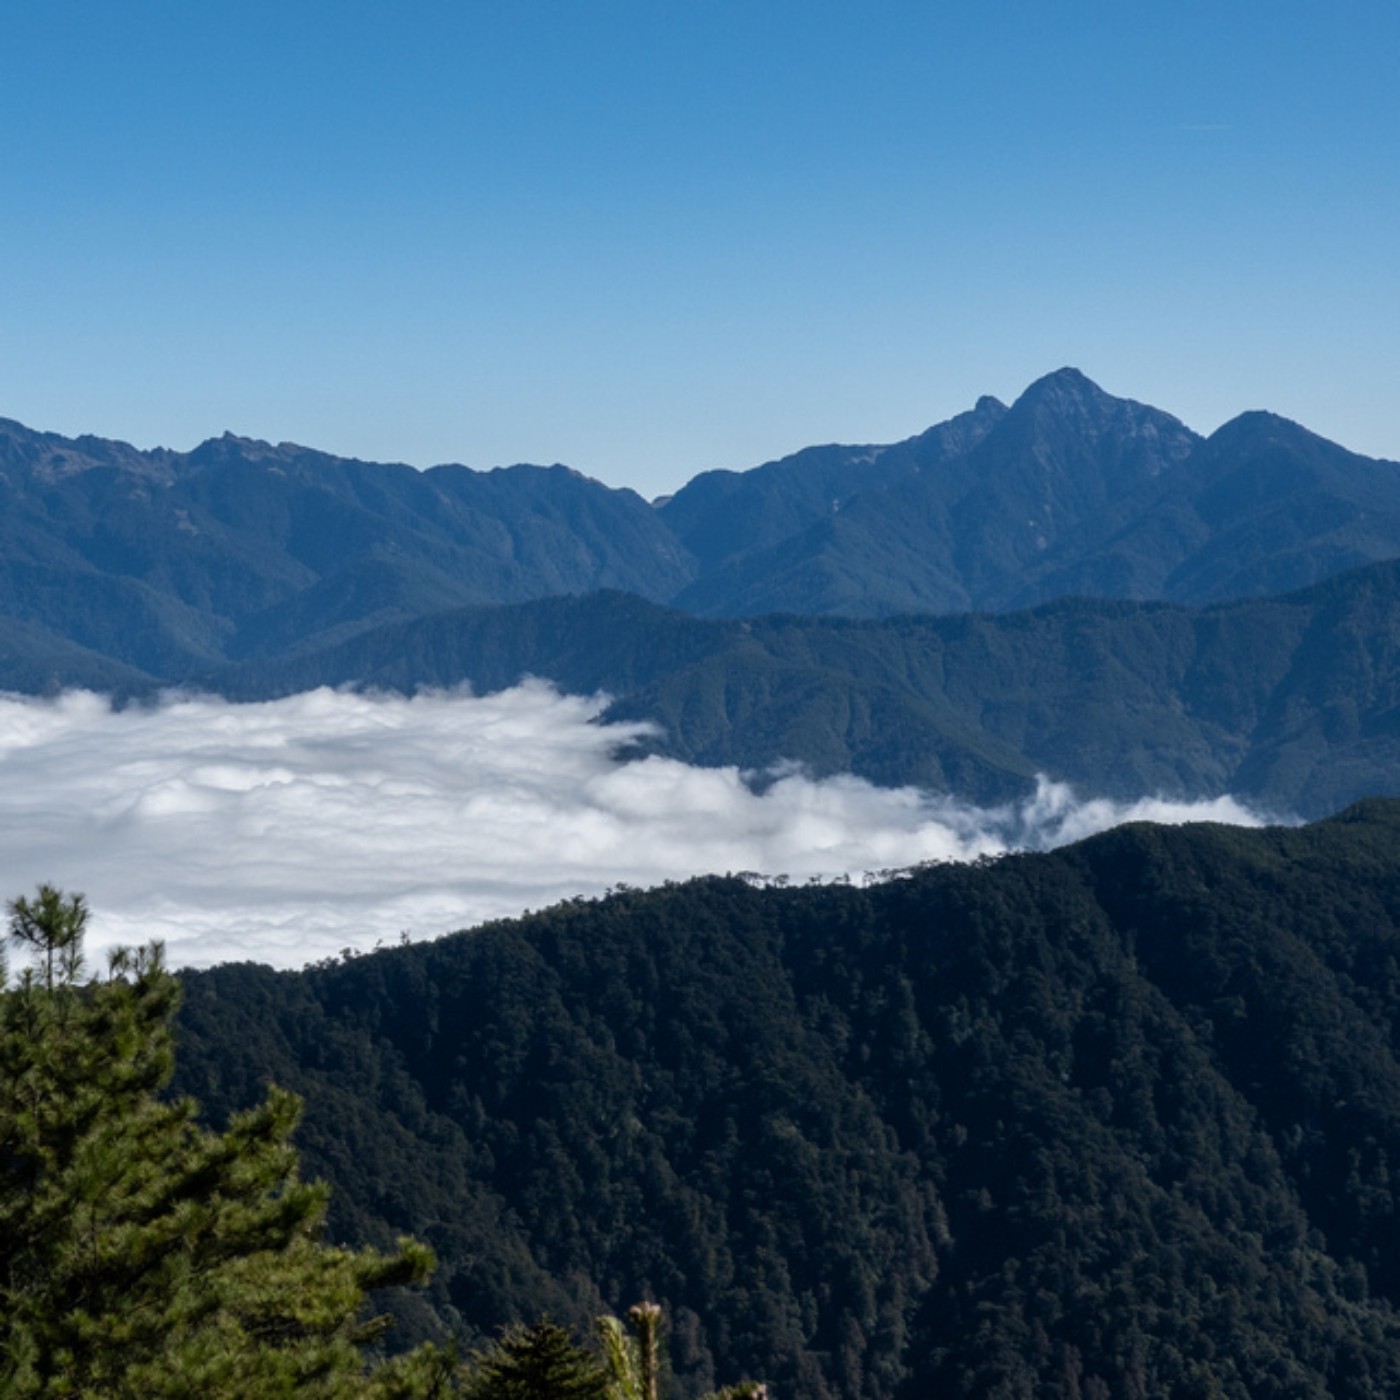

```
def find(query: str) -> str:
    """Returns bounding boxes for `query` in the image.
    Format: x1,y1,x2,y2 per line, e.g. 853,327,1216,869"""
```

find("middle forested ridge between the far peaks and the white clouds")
213,563,1400,816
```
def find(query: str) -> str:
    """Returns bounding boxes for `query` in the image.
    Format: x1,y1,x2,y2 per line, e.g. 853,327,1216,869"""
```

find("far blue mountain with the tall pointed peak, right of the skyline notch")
662,370,1400,617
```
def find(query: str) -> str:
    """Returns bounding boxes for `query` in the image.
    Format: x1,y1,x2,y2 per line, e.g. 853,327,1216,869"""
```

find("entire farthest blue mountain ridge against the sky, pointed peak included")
8,370,1400,690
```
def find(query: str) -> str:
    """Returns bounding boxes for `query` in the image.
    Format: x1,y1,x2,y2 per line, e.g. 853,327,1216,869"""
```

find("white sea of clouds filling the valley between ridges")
0,683,1261,967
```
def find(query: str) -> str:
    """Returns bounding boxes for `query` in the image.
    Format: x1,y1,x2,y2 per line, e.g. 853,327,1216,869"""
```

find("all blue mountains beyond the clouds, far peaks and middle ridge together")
0,370,1400,818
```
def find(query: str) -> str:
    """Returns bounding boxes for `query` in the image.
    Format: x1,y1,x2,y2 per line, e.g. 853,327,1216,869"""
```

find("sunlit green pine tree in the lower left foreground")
0,886,452,1400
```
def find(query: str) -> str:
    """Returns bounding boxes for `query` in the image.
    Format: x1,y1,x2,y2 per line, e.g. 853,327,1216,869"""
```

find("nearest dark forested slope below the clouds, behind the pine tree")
169,802,1400,1400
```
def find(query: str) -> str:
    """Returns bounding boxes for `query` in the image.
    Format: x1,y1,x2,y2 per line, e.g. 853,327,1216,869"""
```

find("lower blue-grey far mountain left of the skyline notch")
0,421,693,685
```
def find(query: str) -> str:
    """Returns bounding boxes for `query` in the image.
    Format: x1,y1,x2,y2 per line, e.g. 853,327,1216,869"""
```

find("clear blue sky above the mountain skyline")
0,0,1400,494
